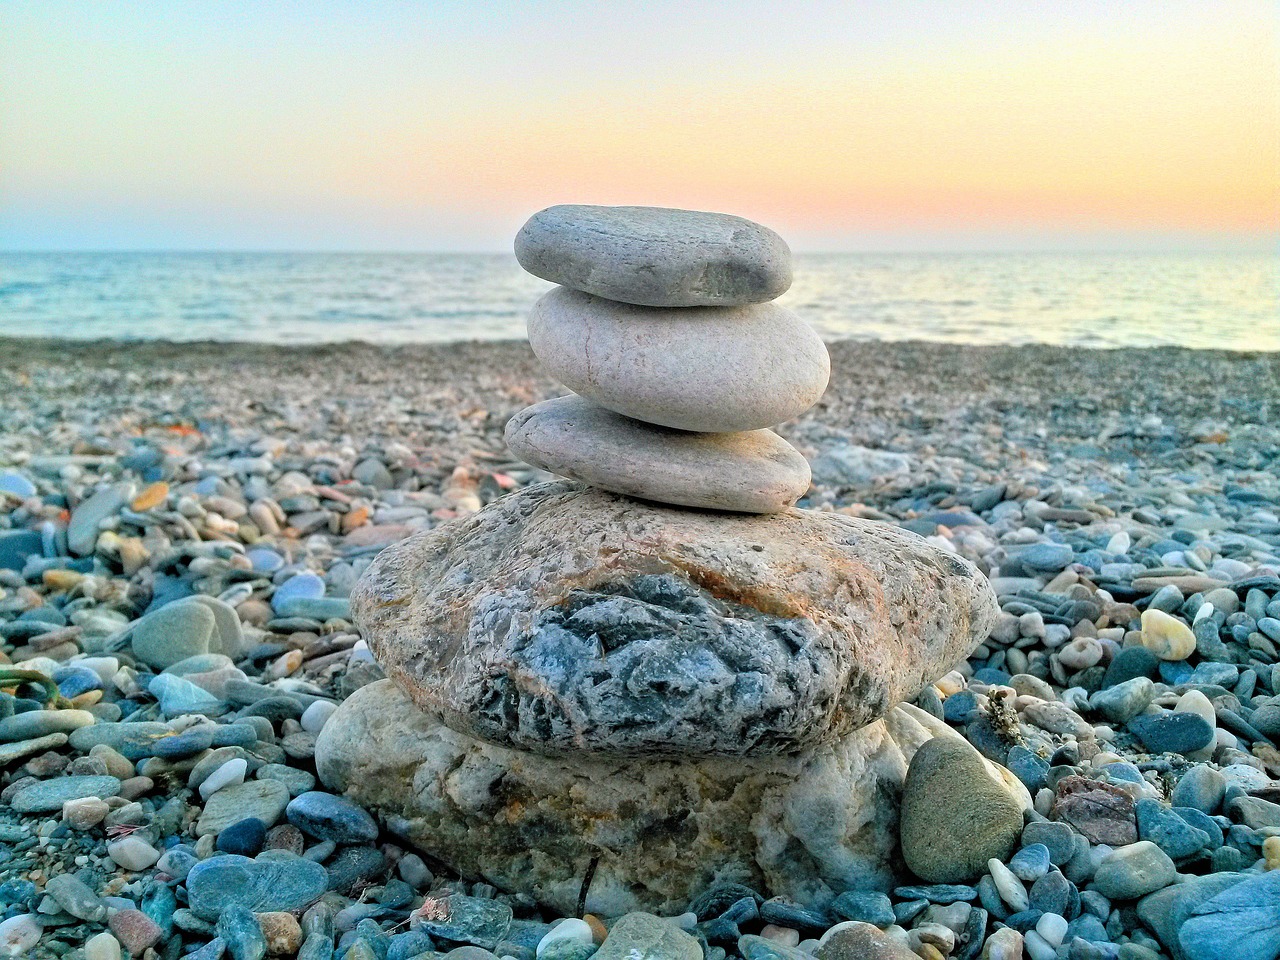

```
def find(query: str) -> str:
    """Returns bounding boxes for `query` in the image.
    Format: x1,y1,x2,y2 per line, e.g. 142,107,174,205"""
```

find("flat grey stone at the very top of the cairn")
516,204,791,307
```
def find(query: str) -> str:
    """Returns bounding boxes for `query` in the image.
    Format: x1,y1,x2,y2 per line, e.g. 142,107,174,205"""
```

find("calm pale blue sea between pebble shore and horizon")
0,253,1280,351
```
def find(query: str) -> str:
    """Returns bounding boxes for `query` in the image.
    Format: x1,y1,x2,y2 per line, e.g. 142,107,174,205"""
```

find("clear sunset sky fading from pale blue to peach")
0,0,1280,251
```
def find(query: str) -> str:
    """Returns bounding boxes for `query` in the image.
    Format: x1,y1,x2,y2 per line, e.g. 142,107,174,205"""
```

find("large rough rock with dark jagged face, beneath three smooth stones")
352,481,997,756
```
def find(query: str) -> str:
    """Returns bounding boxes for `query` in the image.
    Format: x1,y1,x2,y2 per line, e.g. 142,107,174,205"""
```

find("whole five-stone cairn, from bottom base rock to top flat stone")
316,206,1008,915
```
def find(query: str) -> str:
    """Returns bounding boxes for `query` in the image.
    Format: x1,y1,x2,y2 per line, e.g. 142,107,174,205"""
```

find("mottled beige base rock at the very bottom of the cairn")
316,680,1029,915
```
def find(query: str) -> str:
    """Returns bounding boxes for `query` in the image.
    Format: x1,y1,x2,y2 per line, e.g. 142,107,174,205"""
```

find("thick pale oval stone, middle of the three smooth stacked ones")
529,287,831,433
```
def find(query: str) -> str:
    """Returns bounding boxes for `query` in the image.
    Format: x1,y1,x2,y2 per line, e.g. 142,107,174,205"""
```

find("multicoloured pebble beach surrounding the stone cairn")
0,339,1280,960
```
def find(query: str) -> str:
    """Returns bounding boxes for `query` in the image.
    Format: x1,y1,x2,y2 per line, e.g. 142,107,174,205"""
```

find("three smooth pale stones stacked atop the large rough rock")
507,206,831,513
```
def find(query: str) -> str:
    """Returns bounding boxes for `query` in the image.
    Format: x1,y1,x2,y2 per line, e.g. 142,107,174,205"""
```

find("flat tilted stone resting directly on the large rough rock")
506,396,809,513
